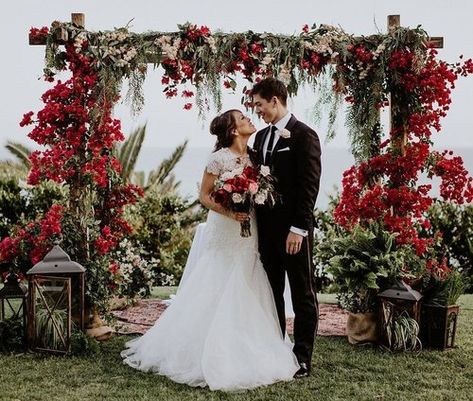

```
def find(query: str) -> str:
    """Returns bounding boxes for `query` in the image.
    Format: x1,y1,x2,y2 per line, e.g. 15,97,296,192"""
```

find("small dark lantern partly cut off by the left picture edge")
0,270,27,347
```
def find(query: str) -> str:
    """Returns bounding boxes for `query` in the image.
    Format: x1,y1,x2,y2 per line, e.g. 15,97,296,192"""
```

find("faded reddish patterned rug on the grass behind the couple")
112,299,348,336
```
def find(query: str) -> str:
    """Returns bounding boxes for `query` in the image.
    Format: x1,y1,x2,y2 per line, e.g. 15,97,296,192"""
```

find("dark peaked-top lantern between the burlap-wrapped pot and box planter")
378,281,422,349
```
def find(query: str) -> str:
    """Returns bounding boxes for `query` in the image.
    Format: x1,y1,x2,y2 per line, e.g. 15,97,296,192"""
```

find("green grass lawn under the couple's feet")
0,289,473,401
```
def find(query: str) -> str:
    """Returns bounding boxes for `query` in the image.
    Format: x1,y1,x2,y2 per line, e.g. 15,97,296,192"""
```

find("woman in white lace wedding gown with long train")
122,110,299,391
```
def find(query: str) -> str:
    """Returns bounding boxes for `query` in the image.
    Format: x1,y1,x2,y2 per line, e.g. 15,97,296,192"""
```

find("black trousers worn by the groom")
258,220,318,366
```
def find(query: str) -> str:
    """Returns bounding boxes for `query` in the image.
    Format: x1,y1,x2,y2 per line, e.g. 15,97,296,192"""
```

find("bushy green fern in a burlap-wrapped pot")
320,222,420,344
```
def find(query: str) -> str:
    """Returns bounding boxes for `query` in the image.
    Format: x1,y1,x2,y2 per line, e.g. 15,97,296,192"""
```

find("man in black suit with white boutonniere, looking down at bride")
252,78,321,378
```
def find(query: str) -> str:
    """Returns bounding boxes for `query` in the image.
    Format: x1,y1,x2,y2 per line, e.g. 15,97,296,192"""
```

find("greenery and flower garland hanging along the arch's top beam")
37,19,436,160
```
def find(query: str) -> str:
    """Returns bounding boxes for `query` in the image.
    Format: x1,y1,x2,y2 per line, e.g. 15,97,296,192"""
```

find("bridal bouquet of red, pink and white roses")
212,166,277,237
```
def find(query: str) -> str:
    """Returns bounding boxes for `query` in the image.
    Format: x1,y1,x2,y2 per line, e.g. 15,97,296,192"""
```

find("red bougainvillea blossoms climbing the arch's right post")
334,46,473,260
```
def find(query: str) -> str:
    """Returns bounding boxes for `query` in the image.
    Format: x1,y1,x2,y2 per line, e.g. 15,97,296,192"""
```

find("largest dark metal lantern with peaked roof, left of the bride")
26,245,85,353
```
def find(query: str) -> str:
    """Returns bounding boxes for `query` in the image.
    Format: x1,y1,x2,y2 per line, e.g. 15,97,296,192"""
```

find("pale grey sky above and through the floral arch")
0,0,473,158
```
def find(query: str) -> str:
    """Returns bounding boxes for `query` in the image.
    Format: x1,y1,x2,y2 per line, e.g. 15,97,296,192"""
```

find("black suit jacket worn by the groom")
254,115,321,231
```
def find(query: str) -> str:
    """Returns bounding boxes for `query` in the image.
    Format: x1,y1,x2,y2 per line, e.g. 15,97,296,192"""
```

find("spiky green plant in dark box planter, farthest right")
421,267,465,350
